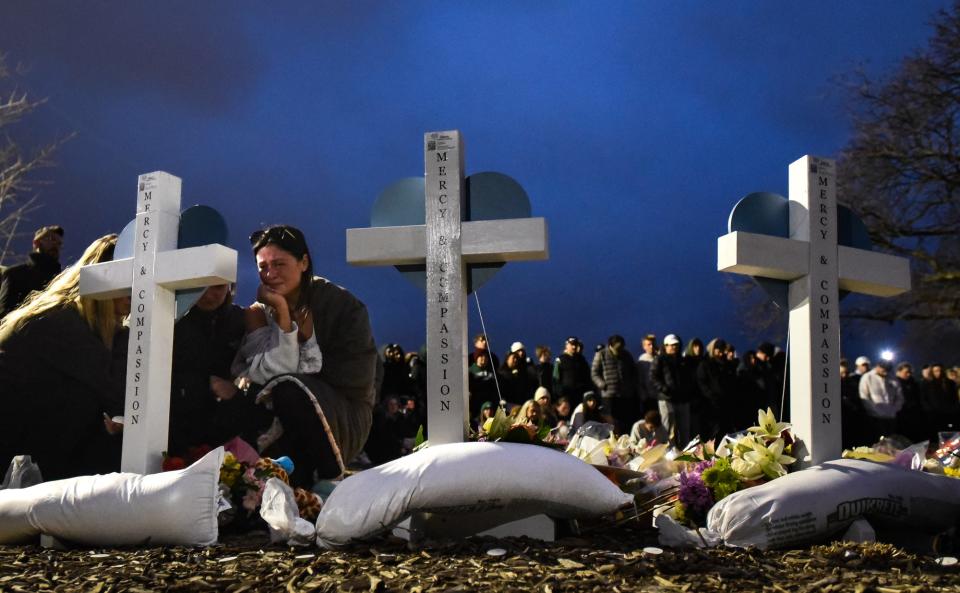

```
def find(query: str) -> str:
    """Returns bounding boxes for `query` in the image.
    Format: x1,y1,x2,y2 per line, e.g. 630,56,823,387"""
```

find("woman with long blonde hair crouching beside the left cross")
0,235,130,480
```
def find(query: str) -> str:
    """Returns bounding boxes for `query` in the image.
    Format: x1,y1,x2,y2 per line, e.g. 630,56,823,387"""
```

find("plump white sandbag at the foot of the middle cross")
317,443,633,548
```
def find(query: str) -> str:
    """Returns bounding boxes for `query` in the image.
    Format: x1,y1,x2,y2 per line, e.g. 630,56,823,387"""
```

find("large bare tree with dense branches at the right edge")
838,0,960,321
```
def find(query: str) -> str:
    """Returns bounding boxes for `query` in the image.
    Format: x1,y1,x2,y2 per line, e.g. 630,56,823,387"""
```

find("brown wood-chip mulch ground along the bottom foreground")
0,528,960,593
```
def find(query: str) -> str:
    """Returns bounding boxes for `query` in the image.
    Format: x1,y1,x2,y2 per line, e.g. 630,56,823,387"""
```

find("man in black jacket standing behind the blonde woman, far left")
0,225,63,319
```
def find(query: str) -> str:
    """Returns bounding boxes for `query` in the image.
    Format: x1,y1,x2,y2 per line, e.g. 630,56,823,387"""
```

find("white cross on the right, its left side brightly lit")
717,156,910,467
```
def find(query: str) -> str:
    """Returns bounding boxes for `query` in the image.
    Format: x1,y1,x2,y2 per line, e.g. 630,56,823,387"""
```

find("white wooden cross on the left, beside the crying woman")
80,171,237,474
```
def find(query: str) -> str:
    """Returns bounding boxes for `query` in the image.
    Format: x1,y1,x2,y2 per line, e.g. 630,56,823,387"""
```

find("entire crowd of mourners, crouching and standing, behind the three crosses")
0,225,960,486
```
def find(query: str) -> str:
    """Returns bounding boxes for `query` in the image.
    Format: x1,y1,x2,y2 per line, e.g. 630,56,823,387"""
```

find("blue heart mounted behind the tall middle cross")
370,172,530,293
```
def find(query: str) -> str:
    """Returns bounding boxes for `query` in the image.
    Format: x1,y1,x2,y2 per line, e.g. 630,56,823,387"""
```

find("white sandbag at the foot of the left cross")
0,447,223,546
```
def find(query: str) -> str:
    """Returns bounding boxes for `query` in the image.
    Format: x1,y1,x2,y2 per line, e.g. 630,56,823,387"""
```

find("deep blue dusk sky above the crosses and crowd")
0,0,947,356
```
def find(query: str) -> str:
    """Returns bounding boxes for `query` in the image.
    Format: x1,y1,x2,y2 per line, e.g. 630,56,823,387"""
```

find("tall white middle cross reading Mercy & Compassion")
347,131,548,444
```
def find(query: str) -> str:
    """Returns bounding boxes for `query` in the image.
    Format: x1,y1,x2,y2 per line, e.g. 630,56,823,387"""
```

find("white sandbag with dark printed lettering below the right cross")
707,459,960,549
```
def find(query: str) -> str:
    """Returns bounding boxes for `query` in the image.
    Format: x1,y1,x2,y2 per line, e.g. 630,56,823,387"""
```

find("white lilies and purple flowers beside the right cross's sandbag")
671,408,796,527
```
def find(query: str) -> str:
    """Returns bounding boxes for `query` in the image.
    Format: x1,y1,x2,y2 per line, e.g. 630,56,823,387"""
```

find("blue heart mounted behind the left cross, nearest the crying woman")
113,205,229,320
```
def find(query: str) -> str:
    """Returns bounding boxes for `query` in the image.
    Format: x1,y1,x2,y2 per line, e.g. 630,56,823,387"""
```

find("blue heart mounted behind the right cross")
727,192,872,309
